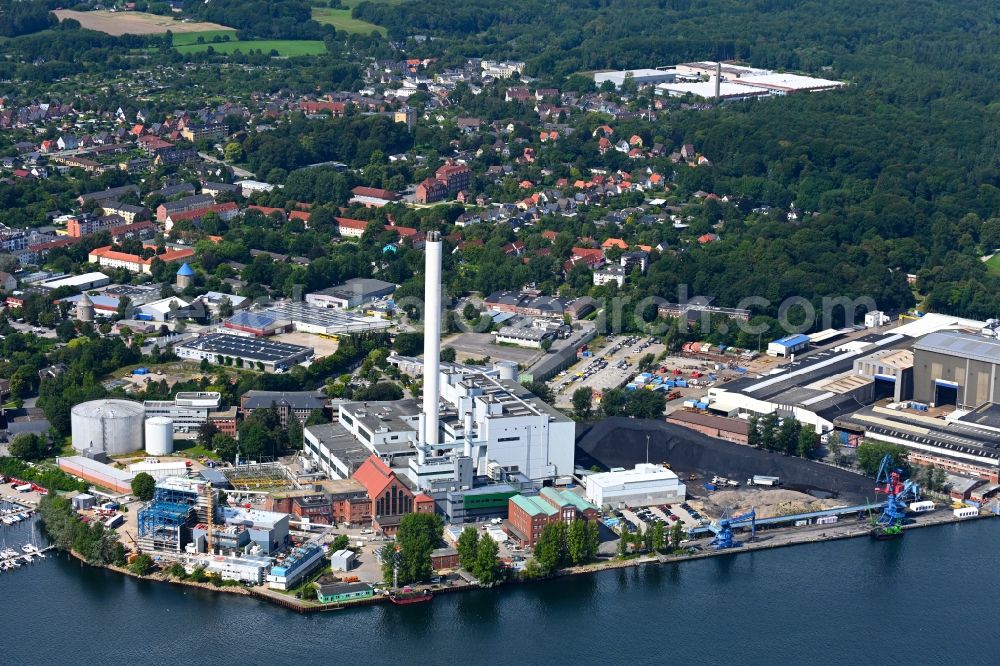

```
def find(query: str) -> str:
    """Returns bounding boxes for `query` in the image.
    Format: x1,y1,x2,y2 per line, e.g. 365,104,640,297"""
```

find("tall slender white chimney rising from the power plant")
424,231,441,446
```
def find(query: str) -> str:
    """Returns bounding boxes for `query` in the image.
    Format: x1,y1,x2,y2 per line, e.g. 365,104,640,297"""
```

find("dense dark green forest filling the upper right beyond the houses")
346,0,1000,317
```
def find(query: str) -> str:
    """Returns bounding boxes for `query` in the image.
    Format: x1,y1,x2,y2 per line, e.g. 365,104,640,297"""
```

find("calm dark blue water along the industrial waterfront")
0,520,1000,666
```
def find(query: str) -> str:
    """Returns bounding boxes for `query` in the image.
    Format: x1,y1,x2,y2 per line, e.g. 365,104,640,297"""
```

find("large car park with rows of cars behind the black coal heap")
551,335,666,406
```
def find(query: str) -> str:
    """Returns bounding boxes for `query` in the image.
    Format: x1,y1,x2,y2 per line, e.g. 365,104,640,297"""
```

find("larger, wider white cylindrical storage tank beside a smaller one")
70,400,146,455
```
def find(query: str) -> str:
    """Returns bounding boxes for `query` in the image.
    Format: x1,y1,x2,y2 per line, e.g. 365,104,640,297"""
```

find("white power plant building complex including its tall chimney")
305,232,575,510
